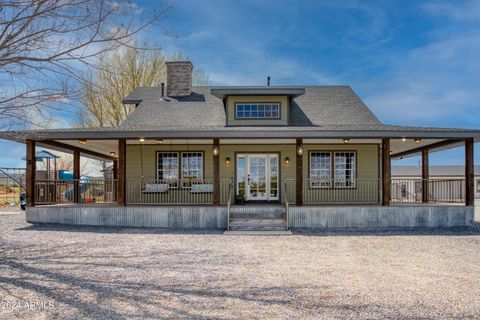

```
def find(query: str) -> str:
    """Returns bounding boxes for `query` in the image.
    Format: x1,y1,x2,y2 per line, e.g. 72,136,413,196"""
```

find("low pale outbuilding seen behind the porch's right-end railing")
392,165,480,202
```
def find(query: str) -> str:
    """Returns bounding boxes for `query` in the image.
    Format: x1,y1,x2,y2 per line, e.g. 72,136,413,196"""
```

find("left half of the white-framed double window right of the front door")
310,152,332,188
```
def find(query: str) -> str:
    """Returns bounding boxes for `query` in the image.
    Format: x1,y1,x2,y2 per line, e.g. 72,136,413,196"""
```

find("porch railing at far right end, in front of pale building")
391,178,465,203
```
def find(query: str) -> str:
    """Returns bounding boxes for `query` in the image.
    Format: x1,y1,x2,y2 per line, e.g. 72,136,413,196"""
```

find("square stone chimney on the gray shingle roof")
165,61,193,97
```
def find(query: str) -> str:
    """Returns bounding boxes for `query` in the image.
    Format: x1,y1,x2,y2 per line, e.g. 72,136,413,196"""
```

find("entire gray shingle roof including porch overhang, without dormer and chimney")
0,86,480,141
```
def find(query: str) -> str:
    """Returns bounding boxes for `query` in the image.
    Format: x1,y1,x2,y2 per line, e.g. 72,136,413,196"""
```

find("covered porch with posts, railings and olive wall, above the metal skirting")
27,138,474,207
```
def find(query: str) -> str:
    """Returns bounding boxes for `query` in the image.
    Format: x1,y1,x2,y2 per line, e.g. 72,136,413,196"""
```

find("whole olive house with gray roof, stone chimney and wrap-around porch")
0,61,480,230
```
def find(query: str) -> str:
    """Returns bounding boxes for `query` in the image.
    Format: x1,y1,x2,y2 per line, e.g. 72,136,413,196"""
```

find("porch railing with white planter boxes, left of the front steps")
126,179,230,205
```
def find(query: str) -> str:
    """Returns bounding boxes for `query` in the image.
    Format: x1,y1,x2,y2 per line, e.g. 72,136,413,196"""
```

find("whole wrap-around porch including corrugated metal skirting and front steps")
22,138,474,230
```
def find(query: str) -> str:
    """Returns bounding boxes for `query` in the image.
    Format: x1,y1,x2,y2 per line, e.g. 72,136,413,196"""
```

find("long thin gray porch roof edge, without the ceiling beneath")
0,124,480,142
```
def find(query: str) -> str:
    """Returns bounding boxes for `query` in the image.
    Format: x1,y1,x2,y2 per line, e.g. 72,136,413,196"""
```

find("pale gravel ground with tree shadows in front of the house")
0,214,480,319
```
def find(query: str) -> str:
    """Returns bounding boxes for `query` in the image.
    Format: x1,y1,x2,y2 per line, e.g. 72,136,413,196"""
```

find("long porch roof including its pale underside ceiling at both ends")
0,125,480,160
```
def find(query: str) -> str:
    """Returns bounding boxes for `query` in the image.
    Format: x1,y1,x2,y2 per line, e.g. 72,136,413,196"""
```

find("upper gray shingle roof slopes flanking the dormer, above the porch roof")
121,86,381,129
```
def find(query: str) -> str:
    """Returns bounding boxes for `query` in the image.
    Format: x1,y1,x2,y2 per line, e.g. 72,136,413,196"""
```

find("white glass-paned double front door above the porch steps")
237,154,279,201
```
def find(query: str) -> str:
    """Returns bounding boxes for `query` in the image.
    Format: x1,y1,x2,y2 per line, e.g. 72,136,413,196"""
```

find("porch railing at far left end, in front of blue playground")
35,178,117,204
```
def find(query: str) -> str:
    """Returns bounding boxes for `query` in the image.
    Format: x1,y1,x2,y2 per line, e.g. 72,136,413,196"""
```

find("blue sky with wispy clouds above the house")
0,0,480,169
